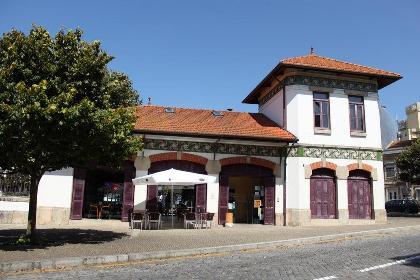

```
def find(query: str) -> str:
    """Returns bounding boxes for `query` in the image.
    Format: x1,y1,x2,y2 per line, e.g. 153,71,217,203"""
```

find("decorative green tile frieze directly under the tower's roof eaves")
259,75,378,106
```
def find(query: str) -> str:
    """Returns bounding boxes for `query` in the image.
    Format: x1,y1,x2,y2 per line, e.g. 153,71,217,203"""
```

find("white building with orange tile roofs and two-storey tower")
0,51,401,226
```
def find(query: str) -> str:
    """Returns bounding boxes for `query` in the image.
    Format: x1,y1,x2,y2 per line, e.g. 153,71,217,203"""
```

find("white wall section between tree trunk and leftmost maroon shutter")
38,168,73,208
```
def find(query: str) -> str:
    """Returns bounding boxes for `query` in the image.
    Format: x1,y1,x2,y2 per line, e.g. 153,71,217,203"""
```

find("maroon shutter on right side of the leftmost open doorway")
121,162,136,222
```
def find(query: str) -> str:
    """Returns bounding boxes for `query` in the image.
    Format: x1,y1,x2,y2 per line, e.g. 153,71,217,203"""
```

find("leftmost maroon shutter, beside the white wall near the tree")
70,168,86,220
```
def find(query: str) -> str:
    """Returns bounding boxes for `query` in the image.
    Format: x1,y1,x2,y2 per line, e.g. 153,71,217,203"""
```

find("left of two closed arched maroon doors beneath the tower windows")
310,168,337,219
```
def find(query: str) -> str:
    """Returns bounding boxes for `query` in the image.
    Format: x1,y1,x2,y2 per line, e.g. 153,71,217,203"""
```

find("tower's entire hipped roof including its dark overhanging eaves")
242,53,402,104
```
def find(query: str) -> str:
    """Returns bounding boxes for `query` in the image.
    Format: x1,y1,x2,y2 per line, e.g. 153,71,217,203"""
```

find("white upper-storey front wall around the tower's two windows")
284,85,381,149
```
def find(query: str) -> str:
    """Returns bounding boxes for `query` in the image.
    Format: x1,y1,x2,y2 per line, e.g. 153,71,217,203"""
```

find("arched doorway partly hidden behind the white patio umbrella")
146,160,207,226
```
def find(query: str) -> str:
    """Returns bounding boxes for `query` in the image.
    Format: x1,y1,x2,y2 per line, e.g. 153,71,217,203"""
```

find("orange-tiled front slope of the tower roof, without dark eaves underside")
280,53,401,78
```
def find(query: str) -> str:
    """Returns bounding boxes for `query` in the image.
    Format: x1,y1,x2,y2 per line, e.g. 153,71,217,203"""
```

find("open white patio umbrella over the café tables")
133,168,216,227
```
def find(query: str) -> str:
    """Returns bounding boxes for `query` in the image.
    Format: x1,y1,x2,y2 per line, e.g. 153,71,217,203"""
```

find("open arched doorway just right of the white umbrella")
219,164,275,225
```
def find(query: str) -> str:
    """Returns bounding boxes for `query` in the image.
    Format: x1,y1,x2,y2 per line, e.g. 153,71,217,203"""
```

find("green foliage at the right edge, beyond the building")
395,139,420,183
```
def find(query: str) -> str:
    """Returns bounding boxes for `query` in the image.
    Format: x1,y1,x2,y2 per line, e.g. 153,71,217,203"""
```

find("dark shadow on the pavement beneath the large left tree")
0,229,129,251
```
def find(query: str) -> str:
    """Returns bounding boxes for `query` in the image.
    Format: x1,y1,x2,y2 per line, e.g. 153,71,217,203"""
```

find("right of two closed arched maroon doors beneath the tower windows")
347,169,372,219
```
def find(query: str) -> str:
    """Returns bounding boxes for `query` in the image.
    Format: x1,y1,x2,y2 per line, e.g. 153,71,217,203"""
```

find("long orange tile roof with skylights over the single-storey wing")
135,105,296,142
